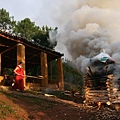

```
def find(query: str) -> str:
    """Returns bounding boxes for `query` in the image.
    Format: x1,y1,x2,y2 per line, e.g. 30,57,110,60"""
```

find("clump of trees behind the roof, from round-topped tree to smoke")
14,18,56,49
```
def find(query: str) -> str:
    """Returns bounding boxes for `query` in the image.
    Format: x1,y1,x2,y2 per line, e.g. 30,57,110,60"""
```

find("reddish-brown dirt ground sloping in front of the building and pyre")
0,91,120,120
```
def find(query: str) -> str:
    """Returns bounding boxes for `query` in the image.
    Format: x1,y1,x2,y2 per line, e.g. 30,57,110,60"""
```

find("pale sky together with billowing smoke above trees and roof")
0,0,120,71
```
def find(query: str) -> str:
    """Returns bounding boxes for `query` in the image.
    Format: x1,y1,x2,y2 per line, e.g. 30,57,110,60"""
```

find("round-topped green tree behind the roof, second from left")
14,18,40,40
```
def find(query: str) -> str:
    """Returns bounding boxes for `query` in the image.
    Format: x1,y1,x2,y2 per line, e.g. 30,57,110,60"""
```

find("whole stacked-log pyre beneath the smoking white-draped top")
84,61,120,105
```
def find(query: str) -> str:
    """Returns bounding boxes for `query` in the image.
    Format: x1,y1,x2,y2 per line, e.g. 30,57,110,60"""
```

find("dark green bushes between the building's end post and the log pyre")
63,60,83,92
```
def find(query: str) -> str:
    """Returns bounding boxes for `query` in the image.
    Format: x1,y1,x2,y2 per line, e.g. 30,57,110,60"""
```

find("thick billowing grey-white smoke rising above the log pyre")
49,0,120,72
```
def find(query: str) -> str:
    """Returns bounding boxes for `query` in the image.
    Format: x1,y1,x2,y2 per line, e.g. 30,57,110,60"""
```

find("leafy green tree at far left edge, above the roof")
0,8,16,33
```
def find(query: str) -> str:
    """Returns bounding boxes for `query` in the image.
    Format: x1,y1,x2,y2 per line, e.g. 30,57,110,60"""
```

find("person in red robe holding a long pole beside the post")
13,62,24,92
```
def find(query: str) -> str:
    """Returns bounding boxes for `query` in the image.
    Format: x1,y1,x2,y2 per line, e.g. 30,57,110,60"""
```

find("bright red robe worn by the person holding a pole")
13,65,24,91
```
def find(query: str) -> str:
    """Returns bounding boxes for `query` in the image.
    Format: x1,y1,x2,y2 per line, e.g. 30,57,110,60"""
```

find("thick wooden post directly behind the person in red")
17,43,26,86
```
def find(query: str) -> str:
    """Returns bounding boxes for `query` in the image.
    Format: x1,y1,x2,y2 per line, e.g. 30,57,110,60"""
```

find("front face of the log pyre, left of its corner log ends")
84,76,109,103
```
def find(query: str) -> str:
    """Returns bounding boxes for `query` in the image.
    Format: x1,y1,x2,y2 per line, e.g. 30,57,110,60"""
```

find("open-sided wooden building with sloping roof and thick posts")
0,31,64,89
